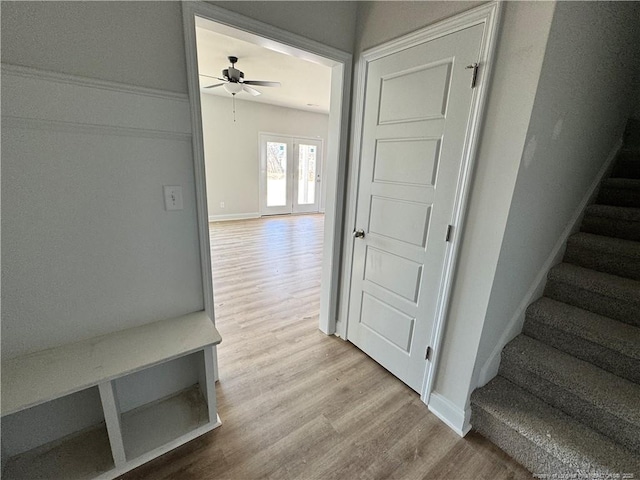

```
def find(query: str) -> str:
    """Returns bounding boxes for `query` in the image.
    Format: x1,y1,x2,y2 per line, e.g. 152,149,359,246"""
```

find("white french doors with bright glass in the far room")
260,133,322,215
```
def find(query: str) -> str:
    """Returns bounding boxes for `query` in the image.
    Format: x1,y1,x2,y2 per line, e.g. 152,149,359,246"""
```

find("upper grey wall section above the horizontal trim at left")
2,1,187,93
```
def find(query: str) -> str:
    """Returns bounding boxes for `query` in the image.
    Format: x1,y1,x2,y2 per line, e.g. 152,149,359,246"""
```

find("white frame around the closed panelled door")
336,2,502,405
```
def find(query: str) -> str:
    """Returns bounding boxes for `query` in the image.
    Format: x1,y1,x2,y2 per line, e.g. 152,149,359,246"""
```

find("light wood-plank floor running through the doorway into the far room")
124,215,531,480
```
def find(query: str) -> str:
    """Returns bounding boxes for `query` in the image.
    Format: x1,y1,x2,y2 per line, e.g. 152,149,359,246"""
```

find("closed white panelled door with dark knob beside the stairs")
347,25,484,391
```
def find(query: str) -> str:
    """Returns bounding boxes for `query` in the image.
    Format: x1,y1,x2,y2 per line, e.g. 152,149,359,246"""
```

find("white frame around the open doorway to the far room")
182,2,352,340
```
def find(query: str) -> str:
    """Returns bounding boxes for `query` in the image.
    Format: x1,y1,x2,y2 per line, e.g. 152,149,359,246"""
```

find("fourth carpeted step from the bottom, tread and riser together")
545,263,640,325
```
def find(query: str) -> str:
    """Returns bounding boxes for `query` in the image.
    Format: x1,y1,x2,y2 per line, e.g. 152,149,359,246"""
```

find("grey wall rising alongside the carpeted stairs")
476,2,640,382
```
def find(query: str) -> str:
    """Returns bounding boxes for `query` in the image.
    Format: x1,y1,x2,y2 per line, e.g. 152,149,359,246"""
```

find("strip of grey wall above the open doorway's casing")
207,1,359,52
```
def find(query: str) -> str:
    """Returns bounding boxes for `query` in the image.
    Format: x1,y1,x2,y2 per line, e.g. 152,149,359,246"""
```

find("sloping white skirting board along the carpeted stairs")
476,134,622,387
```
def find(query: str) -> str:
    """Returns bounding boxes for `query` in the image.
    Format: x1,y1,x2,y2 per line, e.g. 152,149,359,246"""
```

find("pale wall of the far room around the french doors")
201,94,329,218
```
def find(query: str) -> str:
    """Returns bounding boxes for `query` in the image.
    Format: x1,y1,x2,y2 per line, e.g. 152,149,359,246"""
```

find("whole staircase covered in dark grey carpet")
471,120,640,478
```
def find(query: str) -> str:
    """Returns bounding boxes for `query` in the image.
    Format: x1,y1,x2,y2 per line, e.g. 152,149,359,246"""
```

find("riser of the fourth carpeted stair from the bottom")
545,279,640,326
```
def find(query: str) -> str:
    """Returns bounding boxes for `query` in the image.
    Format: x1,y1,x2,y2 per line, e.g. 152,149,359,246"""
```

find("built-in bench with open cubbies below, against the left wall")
1,312,221,479
